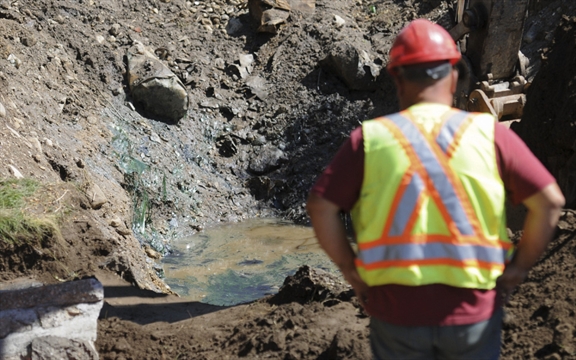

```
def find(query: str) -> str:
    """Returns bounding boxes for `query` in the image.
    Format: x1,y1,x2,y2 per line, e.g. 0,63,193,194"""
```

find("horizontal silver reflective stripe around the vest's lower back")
360,243,507,265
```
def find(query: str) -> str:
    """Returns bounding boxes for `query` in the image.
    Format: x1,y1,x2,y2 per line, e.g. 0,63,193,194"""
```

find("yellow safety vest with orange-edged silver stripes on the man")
351,104,513,289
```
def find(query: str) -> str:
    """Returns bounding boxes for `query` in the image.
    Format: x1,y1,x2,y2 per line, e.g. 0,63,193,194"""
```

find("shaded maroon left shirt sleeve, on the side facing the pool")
310,127,364,212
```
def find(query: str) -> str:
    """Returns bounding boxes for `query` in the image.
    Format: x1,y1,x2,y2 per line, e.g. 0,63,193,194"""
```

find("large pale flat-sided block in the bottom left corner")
0,278,104,360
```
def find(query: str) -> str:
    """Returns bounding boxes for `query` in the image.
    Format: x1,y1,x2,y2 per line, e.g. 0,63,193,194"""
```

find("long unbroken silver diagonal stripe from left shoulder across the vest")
386,113,474,235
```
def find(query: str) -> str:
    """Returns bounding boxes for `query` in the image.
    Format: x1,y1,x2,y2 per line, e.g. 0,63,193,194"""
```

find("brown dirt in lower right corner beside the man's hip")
502,210,576,359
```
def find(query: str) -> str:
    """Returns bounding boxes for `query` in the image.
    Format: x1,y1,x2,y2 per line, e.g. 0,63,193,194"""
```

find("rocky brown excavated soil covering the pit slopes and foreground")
0,0,576,359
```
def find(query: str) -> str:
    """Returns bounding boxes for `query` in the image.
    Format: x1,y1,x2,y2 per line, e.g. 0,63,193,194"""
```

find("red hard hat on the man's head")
387,19,462,72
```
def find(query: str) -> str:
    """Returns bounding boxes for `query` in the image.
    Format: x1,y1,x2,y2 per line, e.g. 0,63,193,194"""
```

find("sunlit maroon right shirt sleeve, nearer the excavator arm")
494,123,556,205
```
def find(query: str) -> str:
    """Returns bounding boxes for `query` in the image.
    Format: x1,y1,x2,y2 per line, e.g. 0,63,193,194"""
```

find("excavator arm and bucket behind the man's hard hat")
450,0,529,121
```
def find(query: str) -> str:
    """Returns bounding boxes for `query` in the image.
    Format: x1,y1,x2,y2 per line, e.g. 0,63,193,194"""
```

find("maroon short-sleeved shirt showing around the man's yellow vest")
311,123,556,326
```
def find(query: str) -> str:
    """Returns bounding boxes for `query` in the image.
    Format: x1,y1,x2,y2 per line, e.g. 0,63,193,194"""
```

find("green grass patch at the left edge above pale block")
0,179,60,245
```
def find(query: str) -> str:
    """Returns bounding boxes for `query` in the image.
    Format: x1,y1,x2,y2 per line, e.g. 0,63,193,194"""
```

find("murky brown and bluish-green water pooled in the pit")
163,219,337,305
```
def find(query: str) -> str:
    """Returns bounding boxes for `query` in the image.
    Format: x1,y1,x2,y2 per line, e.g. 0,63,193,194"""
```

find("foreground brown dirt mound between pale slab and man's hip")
96,266,370,360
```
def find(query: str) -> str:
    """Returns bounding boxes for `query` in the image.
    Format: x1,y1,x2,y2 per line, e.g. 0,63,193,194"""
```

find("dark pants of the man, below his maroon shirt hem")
370,309,503,360
